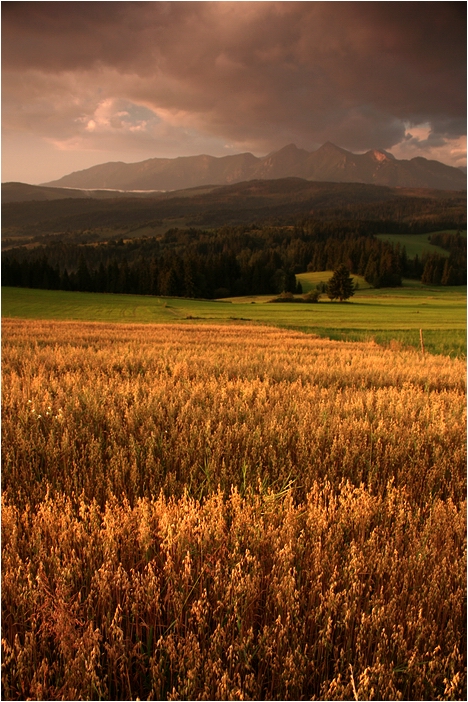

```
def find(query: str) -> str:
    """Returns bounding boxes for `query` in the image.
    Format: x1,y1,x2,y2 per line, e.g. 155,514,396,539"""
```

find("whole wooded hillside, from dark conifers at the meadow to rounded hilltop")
2,178,466,298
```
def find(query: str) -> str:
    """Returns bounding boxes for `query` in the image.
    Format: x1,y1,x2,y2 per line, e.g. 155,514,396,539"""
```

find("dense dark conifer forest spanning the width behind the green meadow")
2,219,466,298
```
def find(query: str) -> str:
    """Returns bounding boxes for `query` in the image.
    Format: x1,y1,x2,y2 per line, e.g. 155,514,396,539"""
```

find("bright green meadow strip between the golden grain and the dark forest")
2,282,466,357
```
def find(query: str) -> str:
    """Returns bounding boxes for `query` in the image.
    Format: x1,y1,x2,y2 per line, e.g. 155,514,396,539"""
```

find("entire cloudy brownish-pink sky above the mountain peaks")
1,2,466,184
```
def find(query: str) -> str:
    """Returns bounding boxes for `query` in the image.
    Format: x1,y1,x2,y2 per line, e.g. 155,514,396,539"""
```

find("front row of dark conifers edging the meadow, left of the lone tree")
2,232,300,298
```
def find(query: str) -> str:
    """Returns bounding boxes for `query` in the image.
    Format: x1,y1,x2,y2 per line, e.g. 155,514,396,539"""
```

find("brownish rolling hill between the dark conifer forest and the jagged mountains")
2,178,466,245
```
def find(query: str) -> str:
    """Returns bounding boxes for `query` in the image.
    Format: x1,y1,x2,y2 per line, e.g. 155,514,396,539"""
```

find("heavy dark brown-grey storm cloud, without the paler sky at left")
2,2,466,158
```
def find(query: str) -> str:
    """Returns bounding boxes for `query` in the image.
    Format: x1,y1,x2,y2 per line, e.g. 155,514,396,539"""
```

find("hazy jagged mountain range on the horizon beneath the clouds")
42,142,466,191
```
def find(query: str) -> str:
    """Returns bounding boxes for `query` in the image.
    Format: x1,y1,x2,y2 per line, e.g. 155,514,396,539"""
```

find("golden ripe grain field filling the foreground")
2,320,466,700
